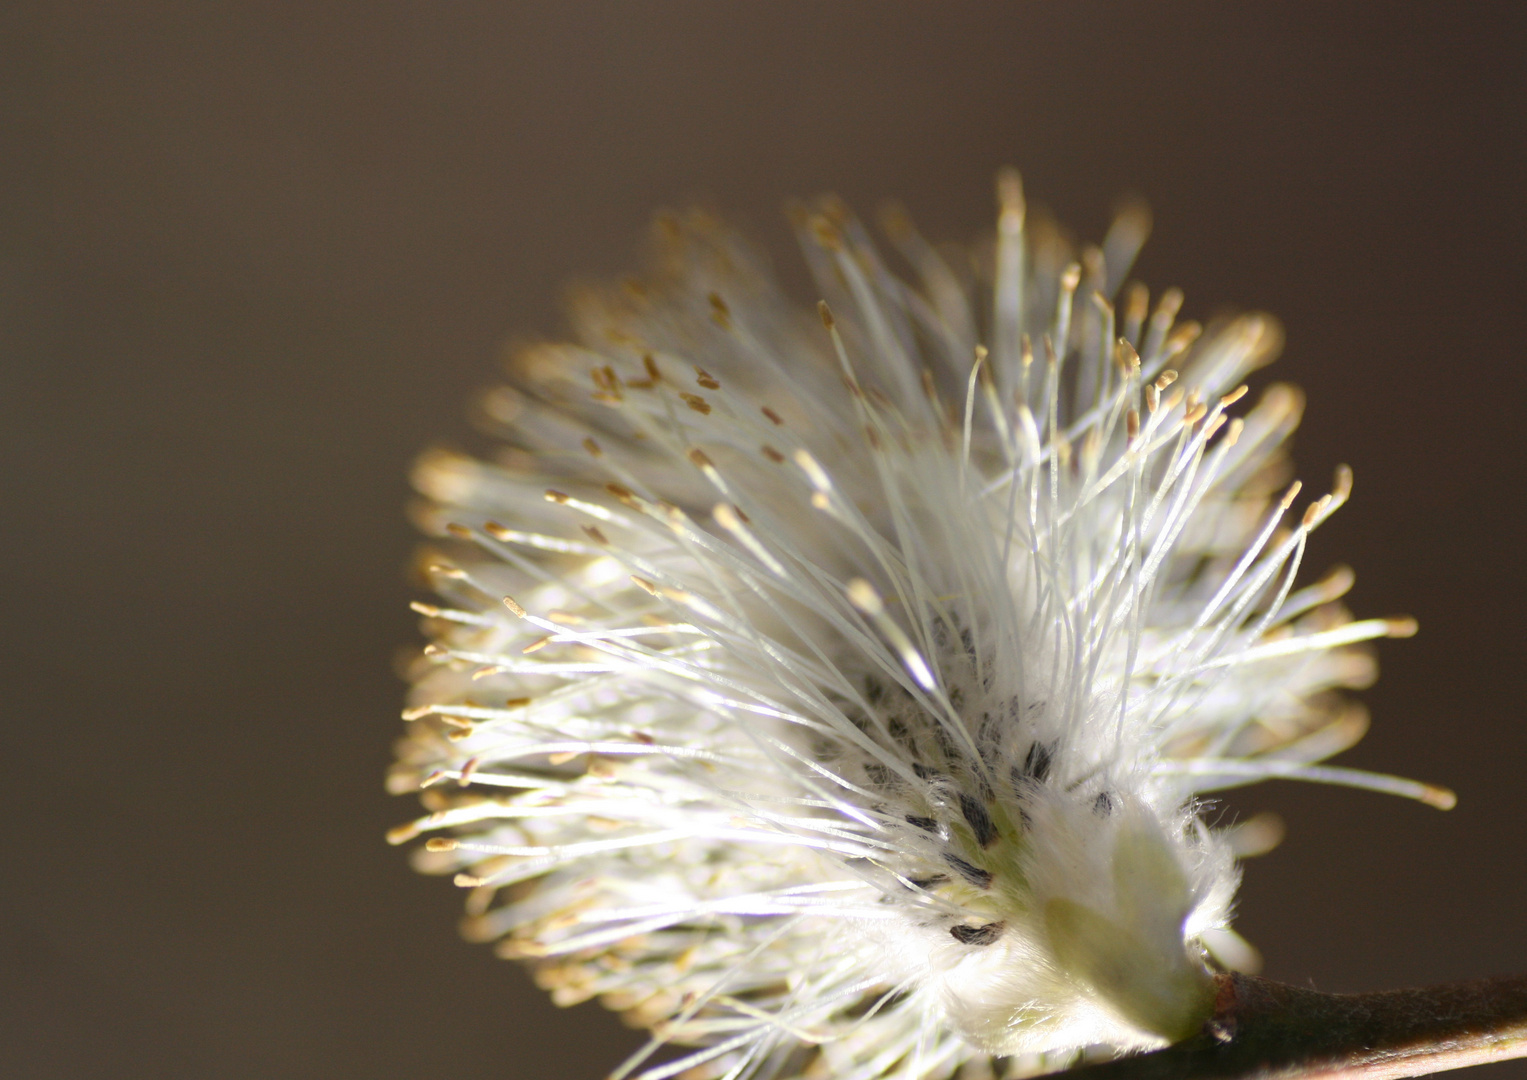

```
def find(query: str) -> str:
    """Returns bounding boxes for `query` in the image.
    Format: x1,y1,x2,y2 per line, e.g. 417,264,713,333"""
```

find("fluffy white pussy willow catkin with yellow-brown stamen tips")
391,173,1451,1080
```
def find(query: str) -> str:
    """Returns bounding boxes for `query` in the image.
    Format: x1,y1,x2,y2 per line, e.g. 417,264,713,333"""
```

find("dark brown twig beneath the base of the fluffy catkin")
1066,975,1527,1080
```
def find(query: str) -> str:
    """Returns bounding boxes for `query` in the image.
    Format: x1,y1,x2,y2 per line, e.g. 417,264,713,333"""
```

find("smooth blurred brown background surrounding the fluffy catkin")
0,0,1527,1080
